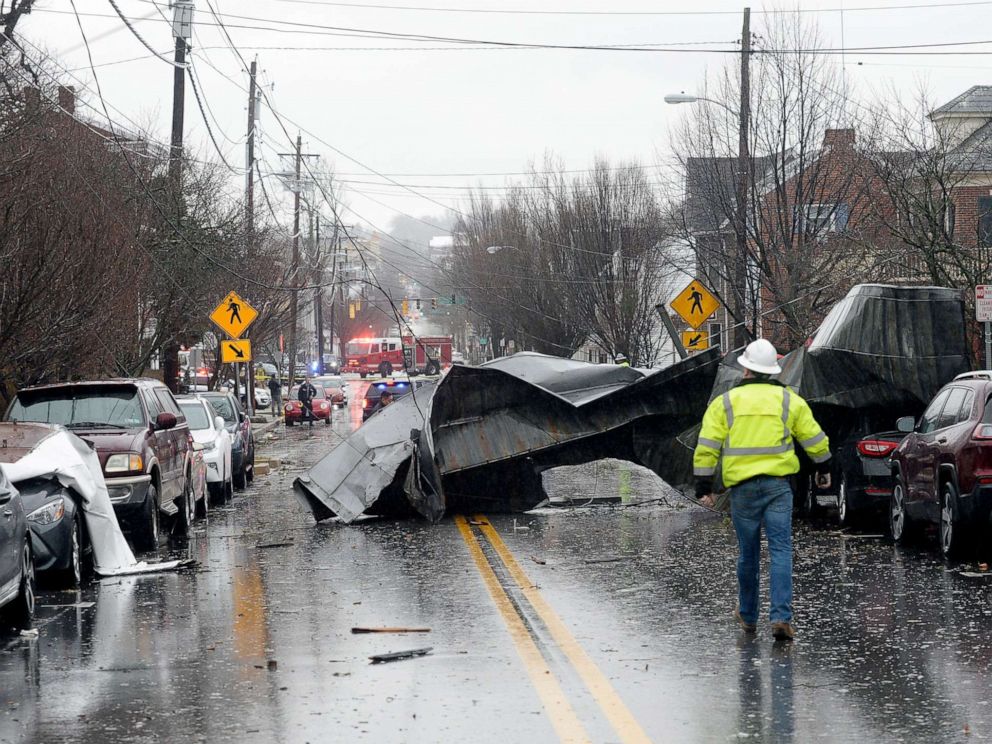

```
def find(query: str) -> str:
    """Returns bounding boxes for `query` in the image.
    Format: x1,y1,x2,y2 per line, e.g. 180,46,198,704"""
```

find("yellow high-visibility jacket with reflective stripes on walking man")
692,379,830,488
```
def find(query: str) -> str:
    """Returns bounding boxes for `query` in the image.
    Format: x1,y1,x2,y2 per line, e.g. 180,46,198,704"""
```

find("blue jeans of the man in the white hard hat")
730,476,792,623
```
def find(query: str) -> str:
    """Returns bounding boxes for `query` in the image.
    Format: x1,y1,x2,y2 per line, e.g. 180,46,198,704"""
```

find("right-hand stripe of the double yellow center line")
475,515,651,744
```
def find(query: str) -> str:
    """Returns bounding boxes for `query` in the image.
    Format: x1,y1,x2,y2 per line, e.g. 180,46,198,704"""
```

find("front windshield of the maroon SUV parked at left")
7,385,145,429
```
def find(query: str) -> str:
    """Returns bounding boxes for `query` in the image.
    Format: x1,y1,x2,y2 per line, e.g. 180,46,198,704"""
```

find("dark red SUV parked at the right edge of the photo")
889,371,992,556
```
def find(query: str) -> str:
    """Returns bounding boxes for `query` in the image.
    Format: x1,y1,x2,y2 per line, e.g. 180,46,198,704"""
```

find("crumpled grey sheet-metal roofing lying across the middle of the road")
293,350,719,522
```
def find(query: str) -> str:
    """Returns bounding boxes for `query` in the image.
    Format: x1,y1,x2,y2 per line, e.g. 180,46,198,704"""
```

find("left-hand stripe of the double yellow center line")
455,515,591,742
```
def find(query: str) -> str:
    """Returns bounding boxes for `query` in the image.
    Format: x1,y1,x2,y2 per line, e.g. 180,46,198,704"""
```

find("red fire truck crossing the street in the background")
342,336,451,378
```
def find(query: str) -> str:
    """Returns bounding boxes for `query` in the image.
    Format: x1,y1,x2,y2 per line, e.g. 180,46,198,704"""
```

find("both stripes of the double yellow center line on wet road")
455,515,651,744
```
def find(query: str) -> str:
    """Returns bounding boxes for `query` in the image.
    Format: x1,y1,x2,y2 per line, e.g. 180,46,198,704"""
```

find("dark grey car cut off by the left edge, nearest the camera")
0,470,35,630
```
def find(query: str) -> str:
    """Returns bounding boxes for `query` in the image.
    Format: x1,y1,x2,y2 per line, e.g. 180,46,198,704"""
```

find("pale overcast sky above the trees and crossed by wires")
17,0,992,234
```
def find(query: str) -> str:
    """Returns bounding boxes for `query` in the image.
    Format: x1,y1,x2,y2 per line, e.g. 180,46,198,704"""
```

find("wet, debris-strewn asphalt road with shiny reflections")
0,386,992,744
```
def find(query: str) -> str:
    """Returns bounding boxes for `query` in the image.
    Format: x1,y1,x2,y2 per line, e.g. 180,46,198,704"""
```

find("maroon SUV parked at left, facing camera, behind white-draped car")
4,379,196,550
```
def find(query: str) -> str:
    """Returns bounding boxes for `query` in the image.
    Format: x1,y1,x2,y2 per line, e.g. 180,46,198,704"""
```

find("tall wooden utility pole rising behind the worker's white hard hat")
731,8,758,349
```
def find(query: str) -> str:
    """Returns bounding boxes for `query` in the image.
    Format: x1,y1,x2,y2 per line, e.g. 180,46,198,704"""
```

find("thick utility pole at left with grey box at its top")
162,0,193,393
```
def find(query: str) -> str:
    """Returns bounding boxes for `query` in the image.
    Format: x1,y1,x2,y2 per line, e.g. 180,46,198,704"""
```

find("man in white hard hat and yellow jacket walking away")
692,339,830,641
